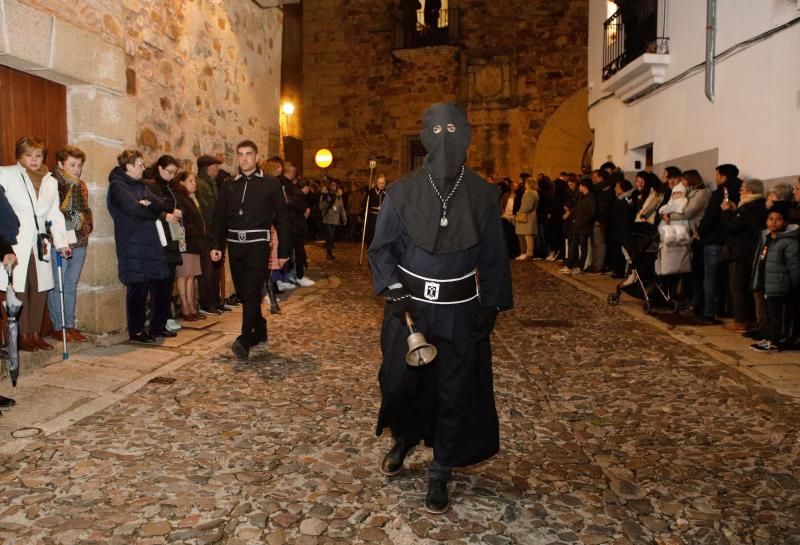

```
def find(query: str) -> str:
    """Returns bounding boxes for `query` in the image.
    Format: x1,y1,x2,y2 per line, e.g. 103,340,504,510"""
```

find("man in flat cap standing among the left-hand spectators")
195,155,227,314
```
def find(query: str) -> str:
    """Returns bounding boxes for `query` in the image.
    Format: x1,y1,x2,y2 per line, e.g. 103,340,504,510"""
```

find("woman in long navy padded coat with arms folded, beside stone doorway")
108,149,169,344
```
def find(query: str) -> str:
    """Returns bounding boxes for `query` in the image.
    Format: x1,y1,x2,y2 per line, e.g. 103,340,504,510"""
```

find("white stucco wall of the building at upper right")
589,0,800,183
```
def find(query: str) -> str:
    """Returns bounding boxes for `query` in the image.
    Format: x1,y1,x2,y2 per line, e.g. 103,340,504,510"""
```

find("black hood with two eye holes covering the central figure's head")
420,103,472,183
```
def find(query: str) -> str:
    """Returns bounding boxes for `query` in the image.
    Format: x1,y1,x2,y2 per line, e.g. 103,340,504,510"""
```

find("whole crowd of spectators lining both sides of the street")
0,132,800,362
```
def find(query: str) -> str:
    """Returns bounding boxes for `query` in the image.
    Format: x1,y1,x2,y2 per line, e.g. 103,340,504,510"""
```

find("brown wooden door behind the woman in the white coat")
0,66,67,344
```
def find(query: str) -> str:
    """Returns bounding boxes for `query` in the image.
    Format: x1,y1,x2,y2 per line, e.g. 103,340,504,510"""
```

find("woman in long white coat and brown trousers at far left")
0,136,72,351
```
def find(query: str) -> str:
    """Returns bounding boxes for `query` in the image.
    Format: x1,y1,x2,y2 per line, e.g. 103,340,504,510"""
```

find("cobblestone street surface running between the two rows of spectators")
0,246,800,545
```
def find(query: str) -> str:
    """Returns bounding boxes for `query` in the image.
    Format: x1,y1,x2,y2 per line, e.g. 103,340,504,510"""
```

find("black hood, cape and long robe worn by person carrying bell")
369,104,513,467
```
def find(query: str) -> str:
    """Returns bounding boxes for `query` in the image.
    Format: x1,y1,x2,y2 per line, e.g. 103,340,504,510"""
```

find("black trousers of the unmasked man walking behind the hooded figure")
228,242,269,348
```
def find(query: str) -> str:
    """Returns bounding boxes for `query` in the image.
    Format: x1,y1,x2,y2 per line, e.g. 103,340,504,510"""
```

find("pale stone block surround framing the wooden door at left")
0,0,130,334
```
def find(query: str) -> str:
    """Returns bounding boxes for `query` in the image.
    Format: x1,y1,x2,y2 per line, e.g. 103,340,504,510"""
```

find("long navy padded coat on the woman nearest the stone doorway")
107,167,169,285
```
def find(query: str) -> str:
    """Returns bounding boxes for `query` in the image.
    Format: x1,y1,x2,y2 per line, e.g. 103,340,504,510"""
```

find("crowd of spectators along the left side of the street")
0,137,386,352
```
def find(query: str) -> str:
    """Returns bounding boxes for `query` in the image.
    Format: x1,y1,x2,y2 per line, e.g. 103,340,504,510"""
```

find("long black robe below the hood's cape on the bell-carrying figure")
369,190,513,467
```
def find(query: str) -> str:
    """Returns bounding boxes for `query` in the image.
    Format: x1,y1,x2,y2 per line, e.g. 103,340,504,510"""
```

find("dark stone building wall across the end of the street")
303,0,590,180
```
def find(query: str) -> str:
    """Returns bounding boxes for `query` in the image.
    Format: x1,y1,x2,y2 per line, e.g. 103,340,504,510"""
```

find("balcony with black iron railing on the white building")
603,0,669,81
